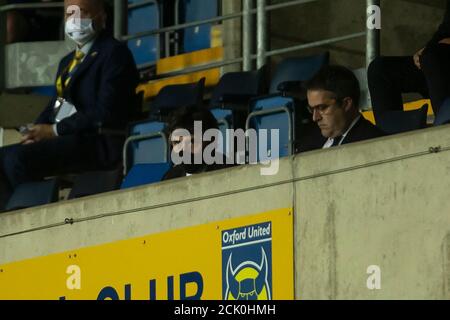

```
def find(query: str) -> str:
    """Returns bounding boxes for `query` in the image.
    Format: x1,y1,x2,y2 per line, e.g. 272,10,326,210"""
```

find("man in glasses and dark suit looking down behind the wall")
297,66,384,152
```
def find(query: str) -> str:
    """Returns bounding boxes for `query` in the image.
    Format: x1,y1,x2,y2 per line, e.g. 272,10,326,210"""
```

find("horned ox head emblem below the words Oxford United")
225,248,271,300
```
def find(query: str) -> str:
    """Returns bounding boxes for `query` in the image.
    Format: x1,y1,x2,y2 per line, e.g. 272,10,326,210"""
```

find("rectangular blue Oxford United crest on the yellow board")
222,222,272,300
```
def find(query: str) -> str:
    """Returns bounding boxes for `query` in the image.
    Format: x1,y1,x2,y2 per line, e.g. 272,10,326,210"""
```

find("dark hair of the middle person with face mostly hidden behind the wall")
167,105,218,135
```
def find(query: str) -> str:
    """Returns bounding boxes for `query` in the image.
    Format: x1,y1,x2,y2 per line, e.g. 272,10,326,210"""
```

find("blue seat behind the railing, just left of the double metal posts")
176,0,219,53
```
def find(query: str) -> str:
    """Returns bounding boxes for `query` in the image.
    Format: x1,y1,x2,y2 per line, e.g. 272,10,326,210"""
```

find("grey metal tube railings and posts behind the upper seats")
0,0,380,89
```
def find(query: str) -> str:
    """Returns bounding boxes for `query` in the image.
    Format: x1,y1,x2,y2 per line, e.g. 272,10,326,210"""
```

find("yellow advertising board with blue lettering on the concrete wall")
0,209,294,300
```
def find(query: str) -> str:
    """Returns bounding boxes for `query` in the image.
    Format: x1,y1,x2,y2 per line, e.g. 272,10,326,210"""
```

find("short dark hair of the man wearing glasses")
304,66,361,108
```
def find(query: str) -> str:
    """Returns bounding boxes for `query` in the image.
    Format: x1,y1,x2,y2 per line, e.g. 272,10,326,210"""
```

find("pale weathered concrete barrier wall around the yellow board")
0,127,450,299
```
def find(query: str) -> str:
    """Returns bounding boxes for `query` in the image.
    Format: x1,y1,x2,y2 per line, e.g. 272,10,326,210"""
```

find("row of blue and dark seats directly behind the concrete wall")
7,53,450,210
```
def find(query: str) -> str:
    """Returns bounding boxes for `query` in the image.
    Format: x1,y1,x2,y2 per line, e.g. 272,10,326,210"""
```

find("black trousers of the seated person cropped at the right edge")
368,44,450,121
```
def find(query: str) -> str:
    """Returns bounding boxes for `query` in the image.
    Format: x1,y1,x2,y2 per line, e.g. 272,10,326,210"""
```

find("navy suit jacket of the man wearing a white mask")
36,33,139,136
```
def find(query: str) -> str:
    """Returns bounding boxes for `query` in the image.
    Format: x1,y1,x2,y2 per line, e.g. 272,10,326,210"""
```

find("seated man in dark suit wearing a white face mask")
0,0,138,210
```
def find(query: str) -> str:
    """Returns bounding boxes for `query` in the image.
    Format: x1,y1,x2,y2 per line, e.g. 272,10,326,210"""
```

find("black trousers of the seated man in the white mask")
0,135,123,211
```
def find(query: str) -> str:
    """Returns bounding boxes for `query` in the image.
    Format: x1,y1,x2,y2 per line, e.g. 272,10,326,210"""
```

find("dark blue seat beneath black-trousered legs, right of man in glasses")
377,104,428,134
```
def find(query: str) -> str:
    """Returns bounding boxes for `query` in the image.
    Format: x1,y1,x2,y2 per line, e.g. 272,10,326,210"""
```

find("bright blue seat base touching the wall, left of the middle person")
121,162,171,189
